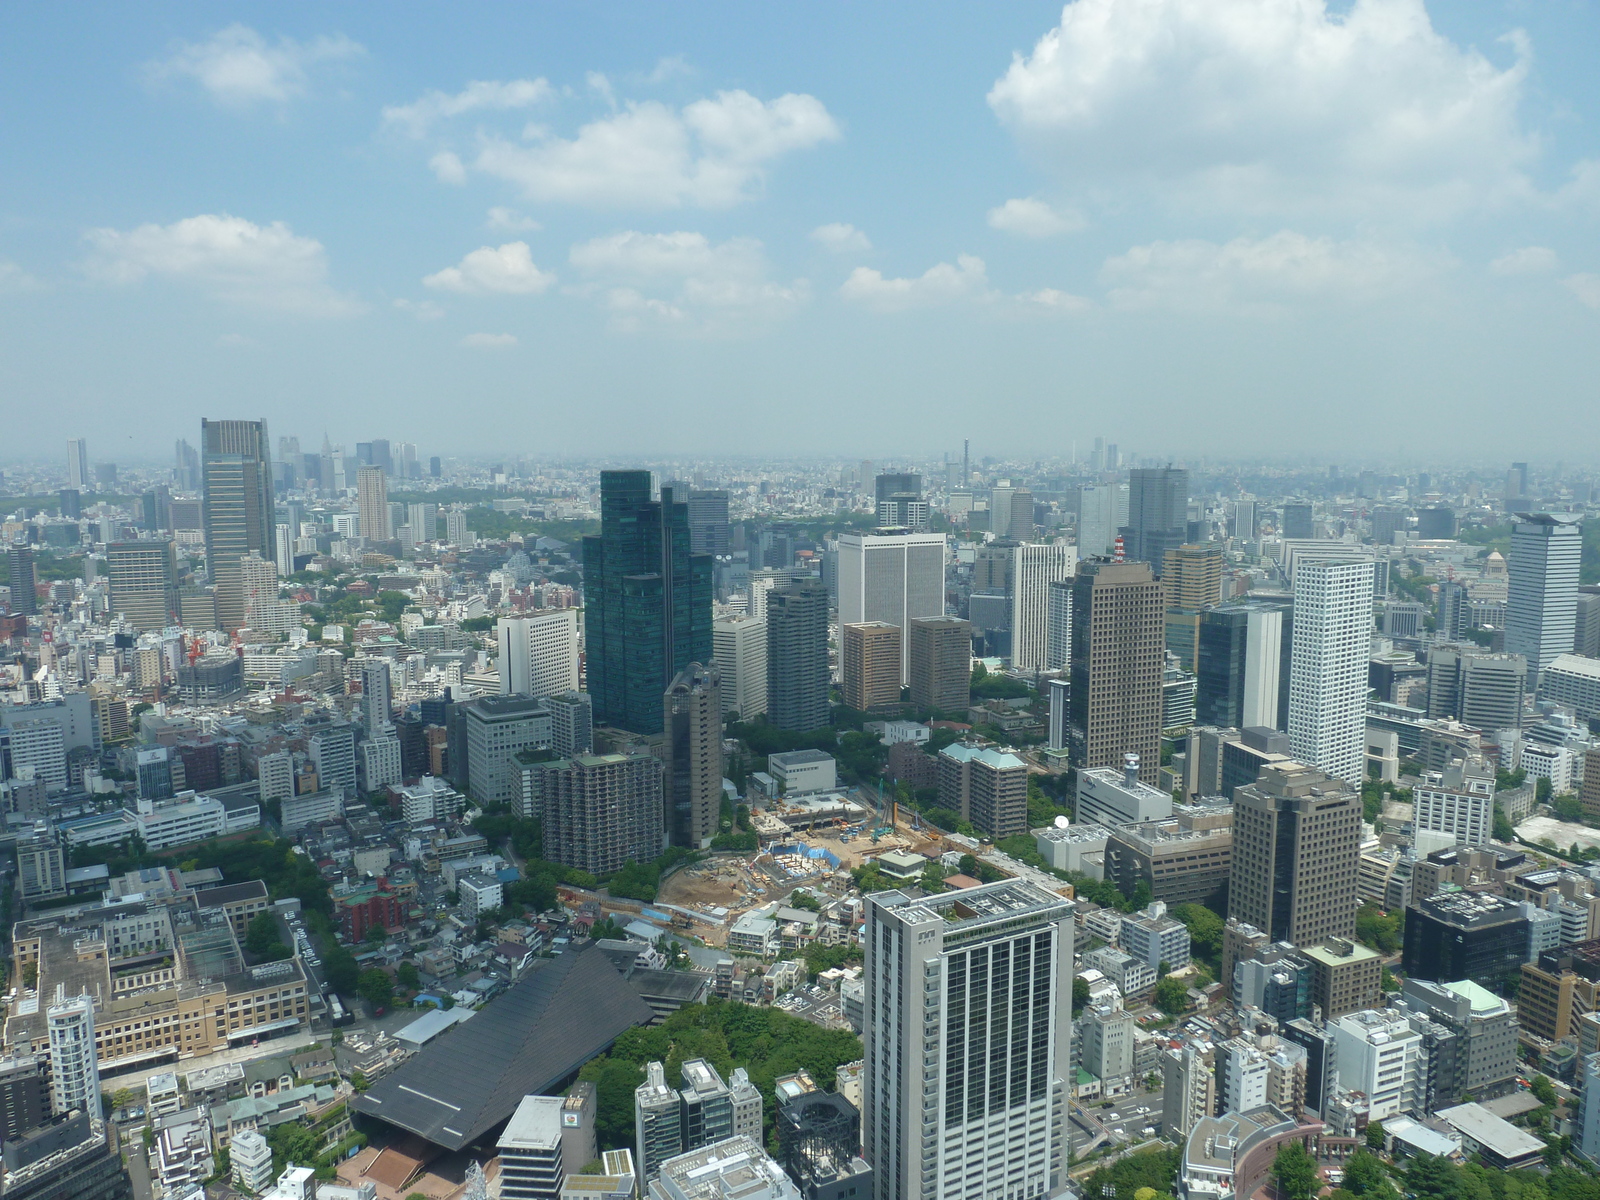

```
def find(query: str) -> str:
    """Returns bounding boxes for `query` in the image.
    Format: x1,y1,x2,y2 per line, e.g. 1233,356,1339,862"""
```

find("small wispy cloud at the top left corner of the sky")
146,24,366,107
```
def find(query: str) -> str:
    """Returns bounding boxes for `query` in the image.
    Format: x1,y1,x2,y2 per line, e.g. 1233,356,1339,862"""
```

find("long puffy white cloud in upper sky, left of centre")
474,91,840,208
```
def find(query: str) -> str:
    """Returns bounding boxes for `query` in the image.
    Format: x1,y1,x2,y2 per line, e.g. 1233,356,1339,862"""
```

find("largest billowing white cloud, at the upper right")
989,0,1538,219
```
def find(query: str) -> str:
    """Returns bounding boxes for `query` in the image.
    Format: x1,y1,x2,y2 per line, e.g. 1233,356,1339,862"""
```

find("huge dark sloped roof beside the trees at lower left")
354,946,653,1150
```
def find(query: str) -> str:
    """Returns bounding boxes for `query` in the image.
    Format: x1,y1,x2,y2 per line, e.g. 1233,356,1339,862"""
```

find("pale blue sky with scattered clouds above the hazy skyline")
0,0,1600,462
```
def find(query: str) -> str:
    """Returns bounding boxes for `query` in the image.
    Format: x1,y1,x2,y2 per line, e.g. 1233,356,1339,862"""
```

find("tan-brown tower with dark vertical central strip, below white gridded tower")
1227,762,1362,946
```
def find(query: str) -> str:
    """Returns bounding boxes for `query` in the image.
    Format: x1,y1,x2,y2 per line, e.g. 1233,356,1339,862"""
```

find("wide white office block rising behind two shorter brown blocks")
838,530,944,682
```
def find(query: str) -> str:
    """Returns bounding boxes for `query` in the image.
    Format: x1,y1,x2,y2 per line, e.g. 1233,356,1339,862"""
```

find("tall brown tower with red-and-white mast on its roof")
1067,558,1166,784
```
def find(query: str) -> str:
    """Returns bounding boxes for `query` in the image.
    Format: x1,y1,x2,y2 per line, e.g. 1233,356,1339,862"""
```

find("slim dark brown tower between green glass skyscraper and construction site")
661,662,722,850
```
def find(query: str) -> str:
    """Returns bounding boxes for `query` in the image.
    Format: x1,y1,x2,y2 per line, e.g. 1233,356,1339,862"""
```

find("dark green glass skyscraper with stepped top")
584,470,712,733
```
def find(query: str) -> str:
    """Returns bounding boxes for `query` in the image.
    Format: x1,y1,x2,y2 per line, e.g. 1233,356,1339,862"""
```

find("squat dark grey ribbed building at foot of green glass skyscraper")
522,752,662,875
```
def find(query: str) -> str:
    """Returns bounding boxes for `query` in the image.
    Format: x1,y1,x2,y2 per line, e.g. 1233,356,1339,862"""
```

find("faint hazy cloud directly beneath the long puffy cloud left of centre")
568,230,810,333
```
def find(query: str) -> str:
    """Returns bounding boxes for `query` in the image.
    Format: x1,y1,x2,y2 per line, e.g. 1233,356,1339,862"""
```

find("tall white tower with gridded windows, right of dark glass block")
1288,558,1373,782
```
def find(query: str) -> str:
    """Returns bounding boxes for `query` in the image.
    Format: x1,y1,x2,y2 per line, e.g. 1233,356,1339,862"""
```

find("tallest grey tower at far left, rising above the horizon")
200,419,275,630
